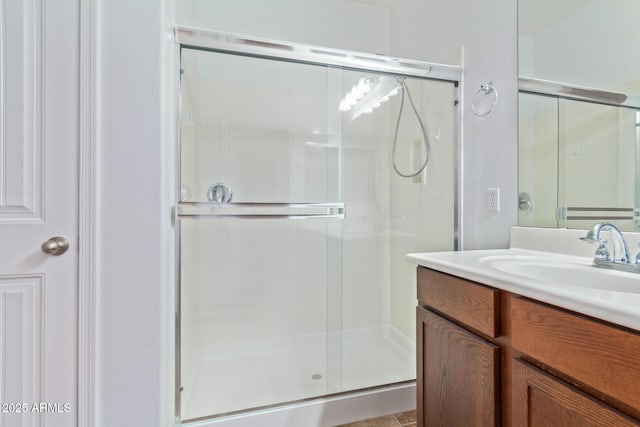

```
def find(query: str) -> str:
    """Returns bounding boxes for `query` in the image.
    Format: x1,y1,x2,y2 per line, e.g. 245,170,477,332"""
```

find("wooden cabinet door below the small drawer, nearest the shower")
417,308,500,427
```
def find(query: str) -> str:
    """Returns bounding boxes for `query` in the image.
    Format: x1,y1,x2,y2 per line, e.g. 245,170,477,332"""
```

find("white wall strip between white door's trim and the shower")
95,0,175,427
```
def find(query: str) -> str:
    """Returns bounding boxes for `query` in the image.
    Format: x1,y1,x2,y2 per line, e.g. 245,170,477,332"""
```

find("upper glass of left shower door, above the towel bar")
181,49,341,203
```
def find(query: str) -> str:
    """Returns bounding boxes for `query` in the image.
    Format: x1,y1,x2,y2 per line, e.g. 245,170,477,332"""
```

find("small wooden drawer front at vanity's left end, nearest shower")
418,267,500,337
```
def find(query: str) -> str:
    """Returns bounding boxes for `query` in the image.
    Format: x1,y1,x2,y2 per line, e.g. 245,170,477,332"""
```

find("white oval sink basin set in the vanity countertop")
479,255,640,293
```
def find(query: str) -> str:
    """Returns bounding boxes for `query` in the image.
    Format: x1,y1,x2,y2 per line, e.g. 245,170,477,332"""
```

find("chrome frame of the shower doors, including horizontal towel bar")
173,26,462,425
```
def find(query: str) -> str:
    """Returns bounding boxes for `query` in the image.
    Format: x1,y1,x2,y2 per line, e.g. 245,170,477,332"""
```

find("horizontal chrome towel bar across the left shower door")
176,202,344,219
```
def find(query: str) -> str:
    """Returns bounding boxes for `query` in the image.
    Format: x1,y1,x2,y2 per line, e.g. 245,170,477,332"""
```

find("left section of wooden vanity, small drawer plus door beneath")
416,268,501,426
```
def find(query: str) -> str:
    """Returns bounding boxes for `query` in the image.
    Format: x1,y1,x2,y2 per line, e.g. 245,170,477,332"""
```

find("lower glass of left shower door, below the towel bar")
181,219,342,420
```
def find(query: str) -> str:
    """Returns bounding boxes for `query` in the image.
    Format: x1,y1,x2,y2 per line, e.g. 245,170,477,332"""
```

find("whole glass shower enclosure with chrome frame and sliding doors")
176,29,460,423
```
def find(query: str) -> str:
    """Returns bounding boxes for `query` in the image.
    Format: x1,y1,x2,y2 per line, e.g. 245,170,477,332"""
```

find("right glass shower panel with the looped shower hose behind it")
342,70,456,391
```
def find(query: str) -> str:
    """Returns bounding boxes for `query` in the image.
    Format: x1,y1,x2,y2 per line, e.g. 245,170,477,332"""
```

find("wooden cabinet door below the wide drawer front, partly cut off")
512,360,640,427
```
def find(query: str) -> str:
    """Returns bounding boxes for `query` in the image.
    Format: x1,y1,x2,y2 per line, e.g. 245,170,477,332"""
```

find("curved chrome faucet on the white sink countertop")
580,222,640,273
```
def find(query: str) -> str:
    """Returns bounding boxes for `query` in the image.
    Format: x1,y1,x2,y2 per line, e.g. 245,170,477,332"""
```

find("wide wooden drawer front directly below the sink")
511,298,640,408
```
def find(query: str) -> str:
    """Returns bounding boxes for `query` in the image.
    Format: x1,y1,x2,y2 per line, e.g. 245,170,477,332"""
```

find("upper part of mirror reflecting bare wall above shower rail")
518,0,640,95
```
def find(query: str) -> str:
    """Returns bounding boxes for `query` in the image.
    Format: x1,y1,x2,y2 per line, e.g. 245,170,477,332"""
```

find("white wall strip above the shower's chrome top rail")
176,0,390,54
